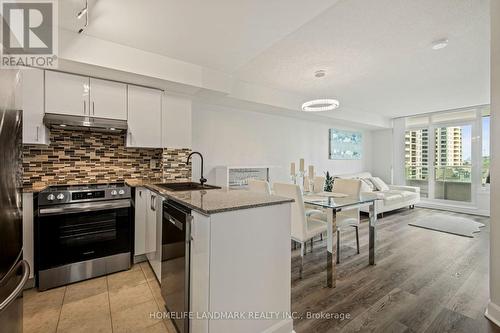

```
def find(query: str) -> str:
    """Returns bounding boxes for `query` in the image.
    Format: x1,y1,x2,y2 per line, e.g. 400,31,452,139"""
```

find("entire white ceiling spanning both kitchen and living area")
59,0,490,117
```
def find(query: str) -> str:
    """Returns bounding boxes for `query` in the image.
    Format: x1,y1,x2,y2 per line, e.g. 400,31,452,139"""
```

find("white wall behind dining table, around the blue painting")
193,102,372,183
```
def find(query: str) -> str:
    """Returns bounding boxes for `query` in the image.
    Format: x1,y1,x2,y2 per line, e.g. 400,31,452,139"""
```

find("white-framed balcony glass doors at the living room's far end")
405,106,489,207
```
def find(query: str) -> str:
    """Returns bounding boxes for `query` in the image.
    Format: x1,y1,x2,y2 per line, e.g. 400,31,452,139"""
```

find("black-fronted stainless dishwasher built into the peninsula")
161,200,192,333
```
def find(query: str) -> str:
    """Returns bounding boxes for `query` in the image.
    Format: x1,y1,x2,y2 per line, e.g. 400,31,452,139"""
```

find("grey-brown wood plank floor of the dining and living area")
292,208,500,333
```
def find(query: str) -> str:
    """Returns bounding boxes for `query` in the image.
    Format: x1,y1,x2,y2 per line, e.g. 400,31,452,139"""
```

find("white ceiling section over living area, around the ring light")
238,0,490,117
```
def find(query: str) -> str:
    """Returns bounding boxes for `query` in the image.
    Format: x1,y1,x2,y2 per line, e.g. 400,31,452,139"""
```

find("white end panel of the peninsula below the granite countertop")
190,203,293,333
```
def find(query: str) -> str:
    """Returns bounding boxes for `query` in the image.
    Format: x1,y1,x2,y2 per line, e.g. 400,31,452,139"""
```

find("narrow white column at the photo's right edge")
486,1,500,326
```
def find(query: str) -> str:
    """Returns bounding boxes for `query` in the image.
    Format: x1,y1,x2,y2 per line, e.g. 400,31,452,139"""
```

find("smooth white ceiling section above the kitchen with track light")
59,0,338,73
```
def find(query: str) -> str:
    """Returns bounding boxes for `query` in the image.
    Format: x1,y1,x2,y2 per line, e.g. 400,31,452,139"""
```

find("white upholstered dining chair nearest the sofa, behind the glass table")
310,178,361,263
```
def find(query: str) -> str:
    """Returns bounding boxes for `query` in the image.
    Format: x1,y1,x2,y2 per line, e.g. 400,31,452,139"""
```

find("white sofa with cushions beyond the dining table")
334,172,420,214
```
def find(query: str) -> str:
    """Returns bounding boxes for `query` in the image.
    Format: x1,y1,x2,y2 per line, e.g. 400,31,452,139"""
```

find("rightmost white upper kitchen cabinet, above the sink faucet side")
162,94,192,149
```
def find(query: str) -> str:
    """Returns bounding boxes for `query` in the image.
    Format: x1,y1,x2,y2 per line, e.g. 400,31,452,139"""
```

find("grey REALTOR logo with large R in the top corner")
1,0,57,68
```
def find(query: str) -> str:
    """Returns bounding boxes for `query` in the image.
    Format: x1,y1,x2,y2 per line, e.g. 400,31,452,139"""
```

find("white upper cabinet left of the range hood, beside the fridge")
15,68,49,145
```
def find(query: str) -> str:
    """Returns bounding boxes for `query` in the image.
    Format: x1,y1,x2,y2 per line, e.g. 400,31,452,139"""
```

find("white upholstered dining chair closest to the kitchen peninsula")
273,183,326,278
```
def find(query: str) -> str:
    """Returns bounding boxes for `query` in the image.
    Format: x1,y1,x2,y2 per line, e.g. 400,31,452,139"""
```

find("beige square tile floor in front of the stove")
24,263,175,333
